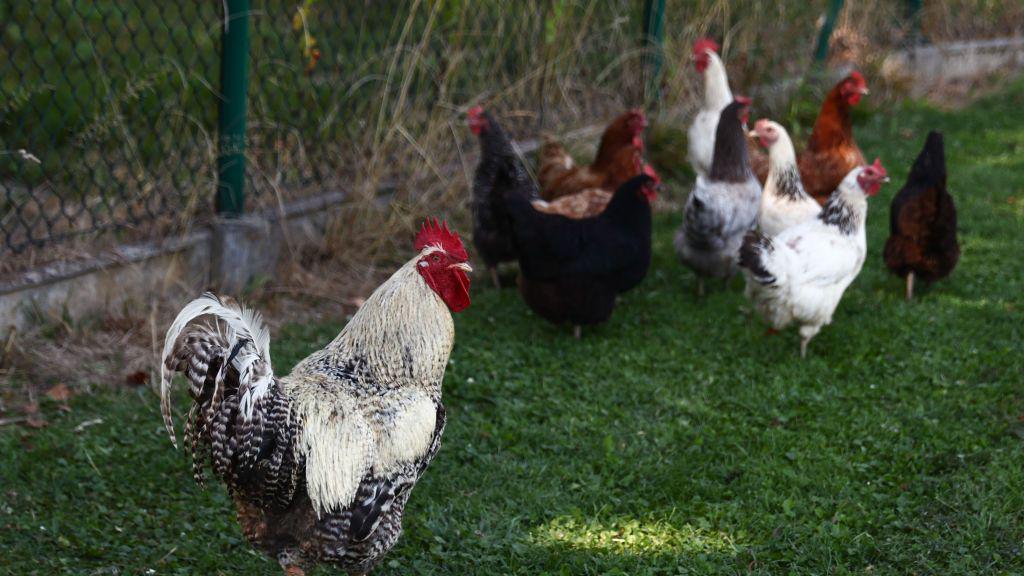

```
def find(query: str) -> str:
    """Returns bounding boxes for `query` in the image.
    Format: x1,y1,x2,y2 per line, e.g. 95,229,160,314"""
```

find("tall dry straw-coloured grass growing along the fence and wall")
0,0,1024,402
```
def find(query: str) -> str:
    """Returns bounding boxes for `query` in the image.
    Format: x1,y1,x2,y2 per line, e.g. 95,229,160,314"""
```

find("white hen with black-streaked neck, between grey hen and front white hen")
751,119,821,237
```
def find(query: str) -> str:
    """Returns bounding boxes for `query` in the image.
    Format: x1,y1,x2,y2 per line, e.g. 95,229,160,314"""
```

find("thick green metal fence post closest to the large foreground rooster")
216,0,249,217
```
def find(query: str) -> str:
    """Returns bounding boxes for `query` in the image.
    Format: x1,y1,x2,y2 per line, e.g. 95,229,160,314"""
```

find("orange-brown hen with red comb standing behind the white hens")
753,72,867,205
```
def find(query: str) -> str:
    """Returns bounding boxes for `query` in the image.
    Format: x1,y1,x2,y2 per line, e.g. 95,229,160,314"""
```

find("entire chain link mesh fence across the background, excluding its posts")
0,0,1020,273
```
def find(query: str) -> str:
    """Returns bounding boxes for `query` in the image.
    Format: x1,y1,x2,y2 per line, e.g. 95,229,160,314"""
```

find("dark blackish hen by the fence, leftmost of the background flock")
467,107,537,288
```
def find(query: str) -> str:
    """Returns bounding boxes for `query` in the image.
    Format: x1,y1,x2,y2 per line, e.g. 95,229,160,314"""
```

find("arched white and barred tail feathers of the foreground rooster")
160,292,273,447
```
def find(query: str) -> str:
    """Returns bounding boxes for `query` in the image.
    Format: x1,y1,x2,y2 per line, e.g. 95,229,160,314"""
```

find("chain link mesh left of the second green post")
0,0,641,264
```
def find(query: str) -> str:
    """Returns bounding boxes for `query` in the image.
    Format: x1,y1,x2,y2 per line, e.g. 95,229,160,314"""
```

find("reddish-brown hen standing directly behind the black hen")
538,110,647,201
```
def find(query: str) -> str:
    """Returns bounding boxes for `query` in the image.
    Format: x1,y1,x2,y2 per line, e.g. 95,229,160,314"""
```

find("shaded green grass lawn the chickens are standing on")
0,77,1024,575
